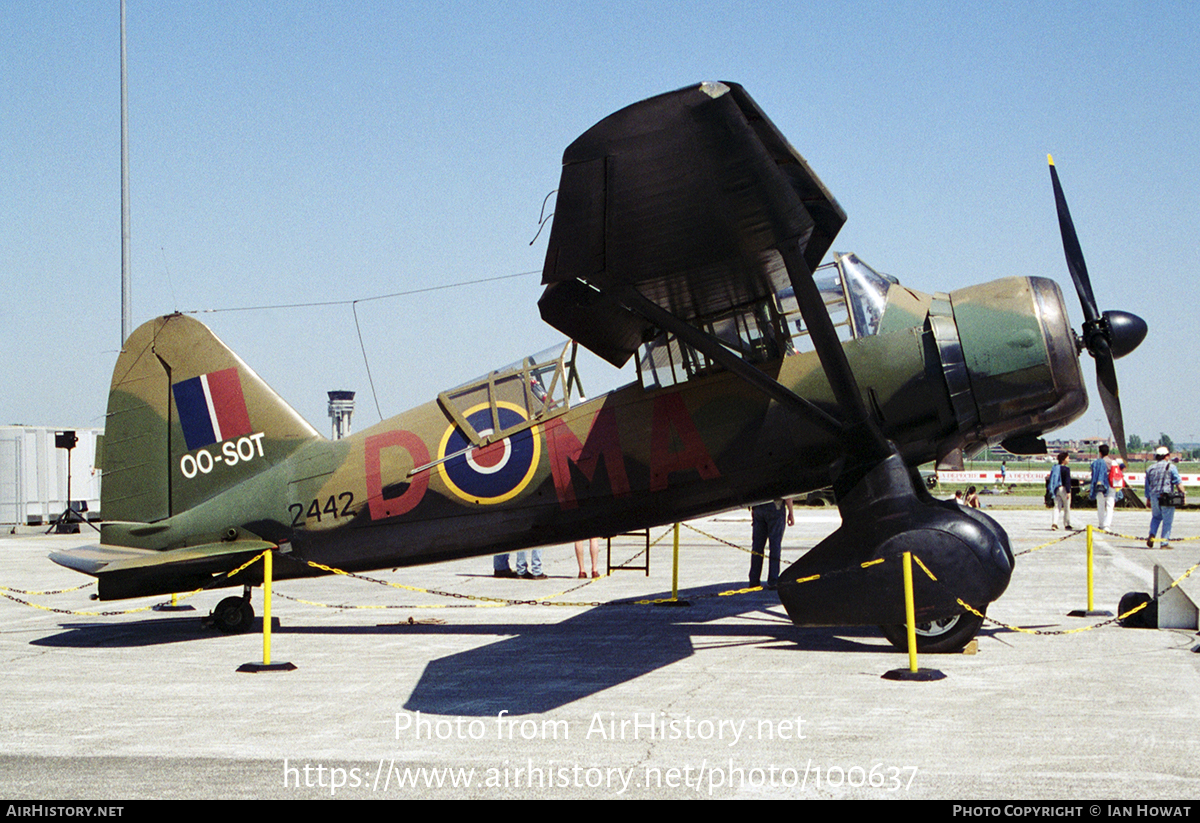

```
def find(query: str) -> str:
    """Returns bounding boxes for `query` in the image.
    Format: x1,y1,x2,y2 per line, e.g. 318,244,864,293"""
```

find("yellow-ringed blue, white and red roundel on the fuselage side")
438,402,541,505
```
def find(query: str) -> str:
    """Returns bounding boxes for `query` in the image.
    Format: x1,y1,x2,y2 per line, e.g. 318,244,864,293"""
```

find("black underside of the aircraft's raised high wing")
538,83,846,366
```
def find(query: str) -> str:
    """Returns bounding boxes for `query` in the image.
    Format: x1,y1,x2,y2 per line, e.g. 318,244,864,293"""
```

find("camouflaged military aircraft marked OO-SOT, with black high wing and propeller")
52,83,1145,650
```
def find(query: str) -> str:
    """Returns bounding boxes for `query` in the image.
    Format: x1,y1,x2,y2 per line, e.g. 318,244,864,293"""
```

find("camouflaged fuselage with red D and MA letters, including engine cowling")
88,267,1086,596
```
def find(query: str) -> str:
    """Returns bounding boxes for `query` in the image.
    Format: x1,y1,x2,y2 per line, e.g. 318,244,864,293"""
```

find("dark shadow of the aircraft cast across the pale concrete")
32,587,1003,716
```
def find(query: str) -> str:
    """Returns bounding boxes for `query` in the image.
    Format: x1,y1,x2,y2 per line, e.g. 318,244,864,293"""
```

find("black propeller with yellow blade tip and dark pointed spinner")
1046,155,1146,463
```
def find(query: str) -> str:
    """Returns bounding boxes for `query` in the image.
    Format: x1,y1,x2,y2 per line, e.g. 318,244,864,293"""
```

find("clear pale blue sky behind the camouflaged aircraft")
0,0,1200,441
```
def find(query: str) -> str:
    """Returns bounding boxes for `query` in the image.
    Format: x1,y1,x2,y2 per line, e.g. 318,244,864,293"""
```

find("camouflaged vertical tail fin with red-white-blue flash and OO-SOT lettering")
101,314,320,523
